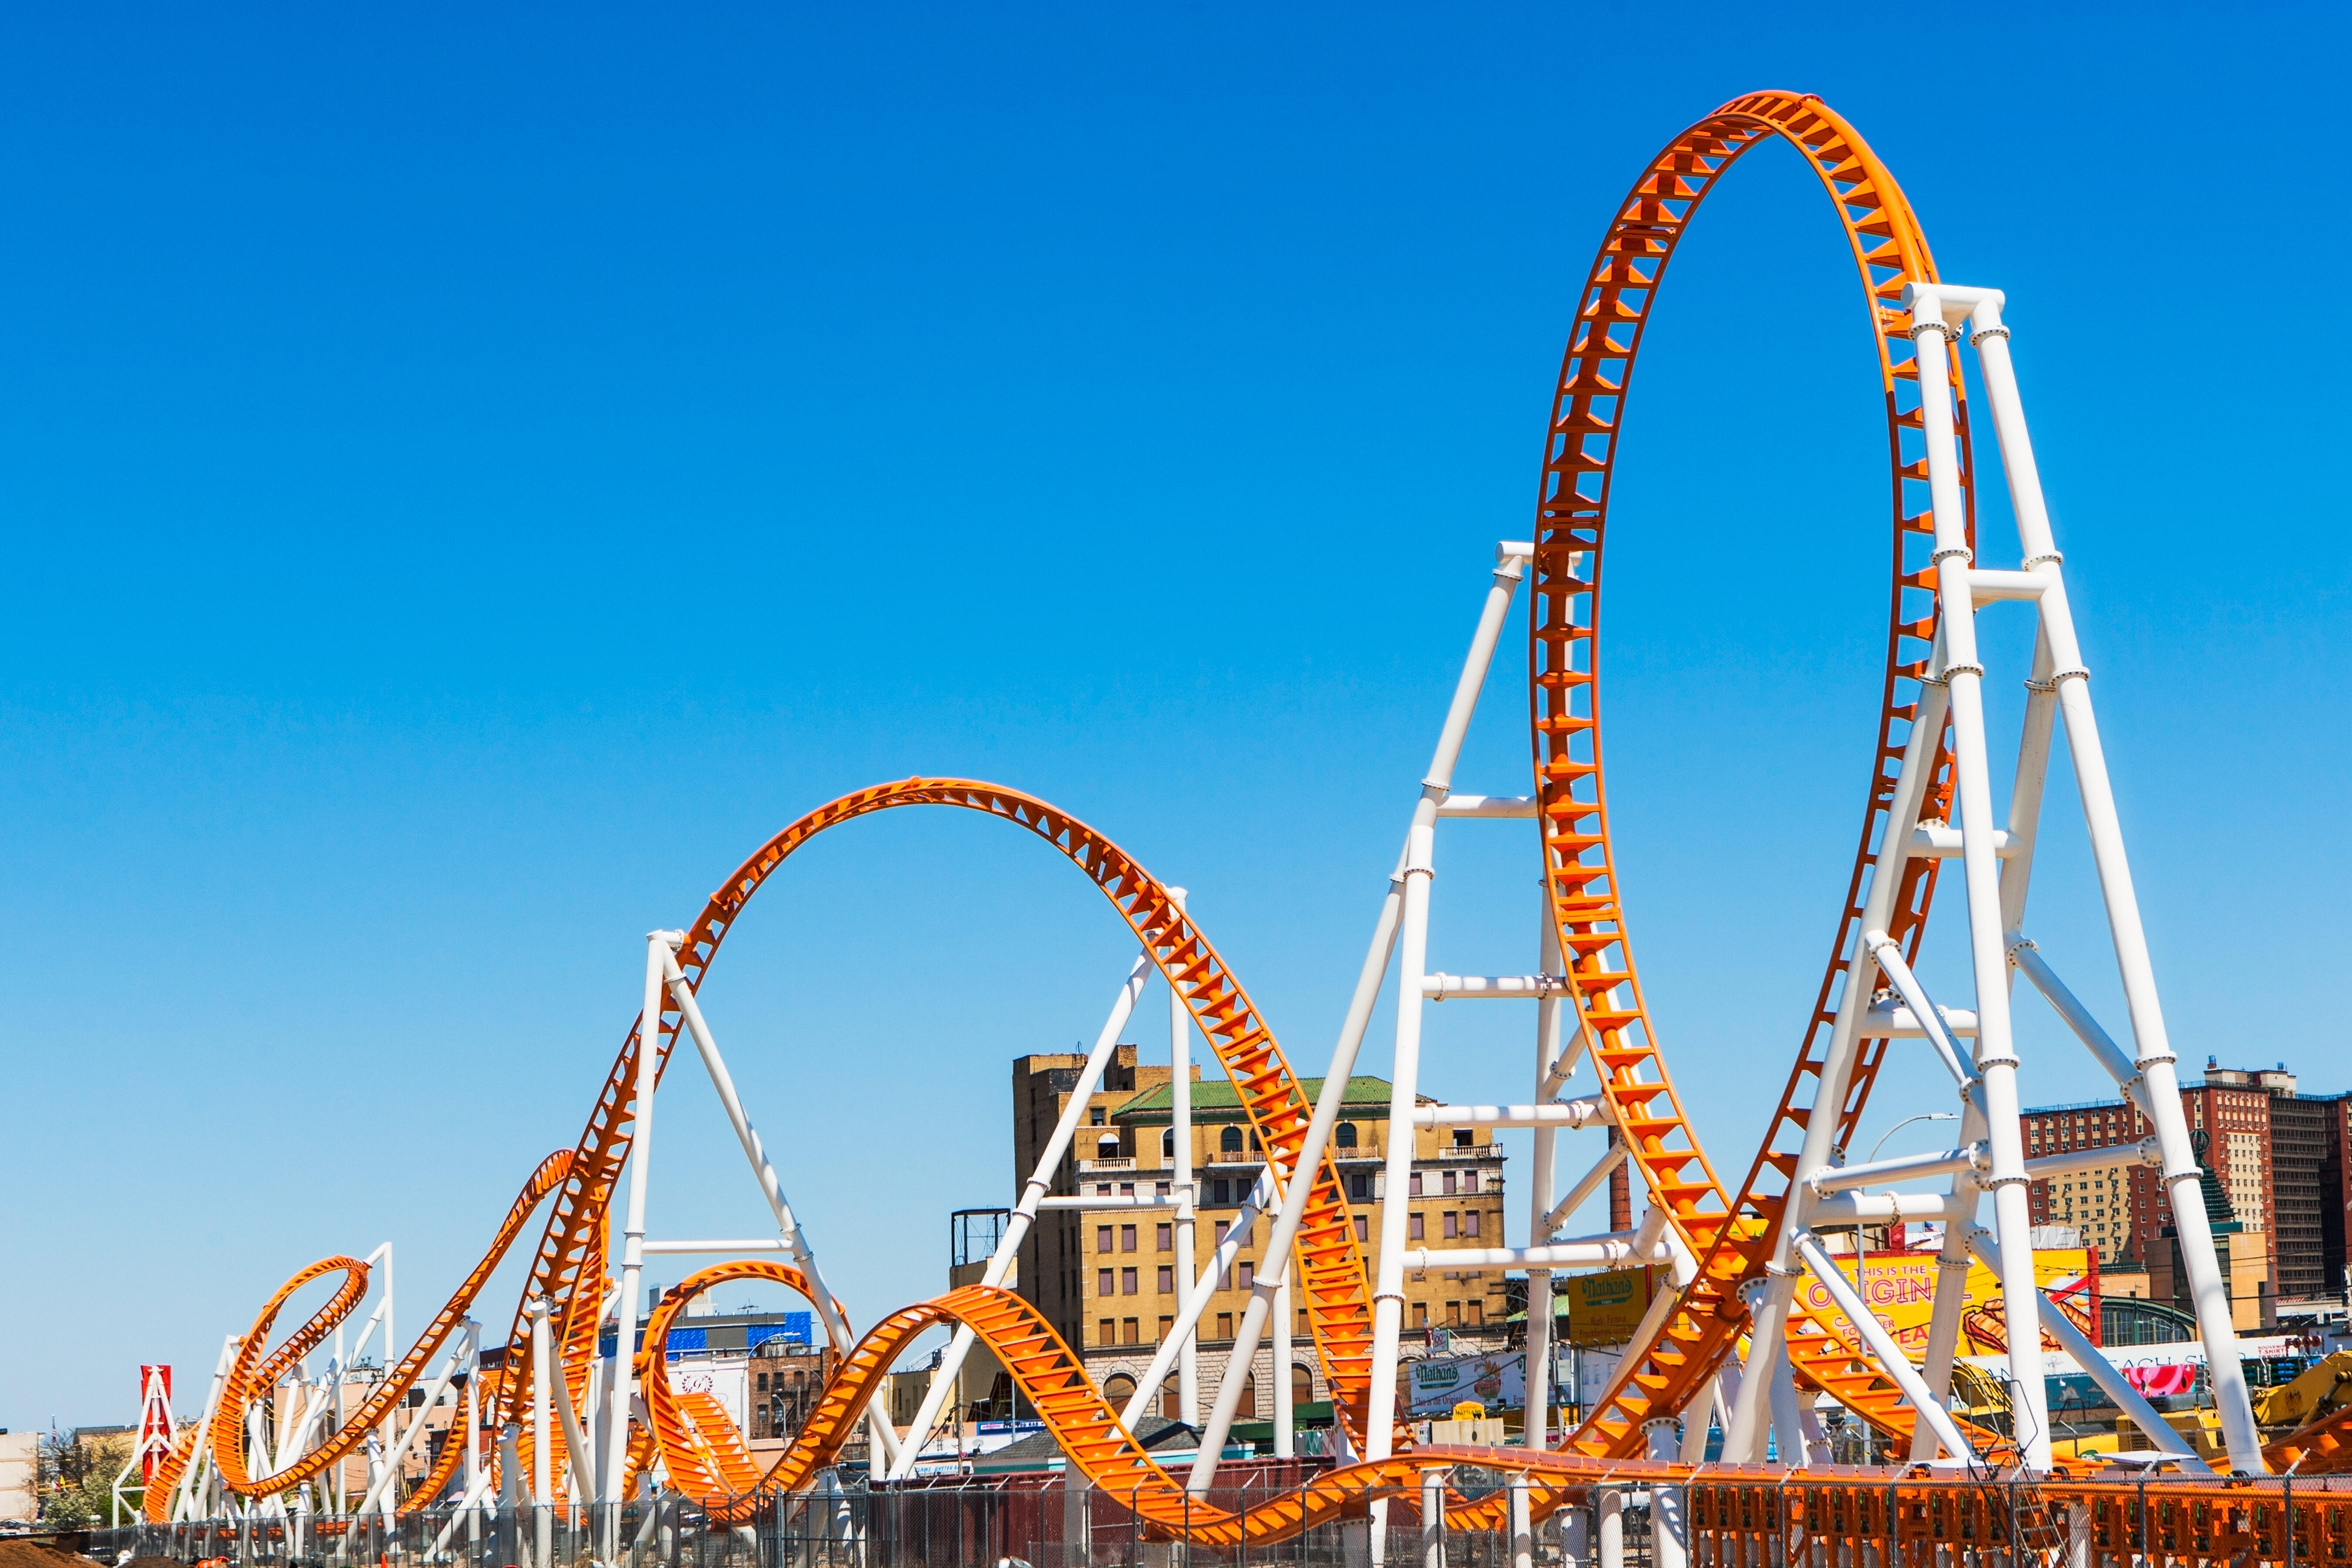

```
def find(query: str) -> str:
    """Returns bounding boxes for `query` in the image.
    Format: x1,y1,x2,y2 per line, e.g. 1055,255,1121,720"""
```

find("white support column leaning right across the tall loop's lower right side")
1724,658,1947,1465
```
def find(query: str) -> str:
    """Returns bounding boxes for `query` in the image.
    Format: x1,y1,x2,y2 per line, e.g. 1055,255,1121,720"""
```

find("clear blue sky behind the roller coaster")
0,5,2352,1429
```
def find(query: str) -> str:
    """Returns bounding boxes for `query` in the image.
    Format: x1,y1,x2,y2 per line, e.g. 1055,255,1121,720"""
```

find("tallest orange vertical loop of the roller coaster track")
1529,91,1974,1457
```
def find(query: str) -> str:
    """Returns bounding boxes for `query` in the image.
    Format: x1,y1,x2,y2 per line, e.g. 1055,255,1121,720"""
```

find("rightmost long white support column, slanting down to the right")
1969,289,2265,1474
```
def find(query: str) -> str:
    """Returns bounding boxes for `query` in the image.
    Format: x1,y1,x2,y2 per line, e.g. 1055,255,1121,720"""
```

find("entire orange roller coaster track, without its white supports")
146,91,2352,1544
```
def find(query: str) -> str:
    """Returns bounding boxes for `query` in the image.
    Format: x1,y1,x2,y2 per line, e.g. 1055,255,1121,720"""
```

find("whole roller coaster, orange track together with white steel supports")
146,91,2352,1563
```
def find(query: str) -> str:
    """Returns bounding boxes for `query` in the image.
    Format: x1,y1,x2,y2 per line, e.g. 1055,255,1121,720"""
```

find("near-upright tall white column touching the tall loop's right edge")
1919,284,2051,1469
